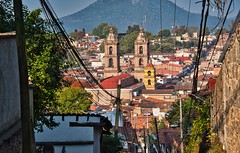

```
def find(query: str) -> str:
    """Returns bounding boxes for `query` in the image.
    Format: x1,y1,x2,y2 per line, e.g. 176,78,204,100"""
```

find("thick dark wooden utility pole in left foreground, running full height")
14,0,34,153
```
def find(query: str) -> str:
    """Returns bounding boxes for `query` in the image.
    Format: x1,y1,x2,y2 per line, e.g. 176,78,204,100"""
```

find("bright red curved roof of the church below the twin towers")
101,73,131,89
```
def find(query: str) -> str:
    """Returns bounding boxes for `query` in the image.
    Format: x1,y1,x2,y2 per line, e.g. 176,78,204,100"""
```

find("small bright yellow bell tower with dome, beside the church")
144,63,156,90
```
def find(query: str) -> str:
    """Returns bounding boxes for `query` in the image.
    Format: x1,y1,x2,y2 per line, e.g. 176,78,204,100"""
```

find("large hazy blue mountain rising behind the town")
60,0,229,34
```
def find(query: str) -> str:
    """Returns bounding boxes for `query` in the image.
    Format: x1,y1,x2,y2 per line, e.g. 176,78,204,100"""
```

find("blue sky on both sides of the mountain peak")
22,0,240,17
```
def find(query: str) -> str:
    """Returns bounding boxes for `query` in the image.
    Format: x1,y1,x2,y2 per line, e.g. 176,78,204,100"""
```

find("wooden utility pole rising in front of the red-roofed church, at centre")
114,80,121,138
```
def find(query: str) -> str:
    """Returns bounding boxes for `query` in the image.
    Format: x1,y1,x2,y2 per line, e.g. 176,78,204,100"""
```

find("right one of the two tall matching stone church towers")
134,29,149,82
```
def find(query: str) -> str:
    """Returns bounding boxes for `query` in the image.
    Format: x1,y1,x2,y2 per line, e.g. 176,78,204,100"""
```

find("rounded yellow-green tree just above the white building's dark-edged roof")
57,87,92,114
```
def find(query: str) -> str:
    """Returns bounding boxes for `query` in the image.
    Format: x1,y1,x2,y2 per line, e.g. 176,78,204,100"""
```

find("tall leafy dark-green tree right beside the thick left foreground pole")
25,9,66,131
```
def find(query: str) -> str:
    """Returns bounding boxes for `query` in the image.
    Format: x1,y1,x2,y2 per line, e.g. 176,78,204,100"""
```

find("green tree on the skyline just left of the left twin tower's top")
92,23,117,39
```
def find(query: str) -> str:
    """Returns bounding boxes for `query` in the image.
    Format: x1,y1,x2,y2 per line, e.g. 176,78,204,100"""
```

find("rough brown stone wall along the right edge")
211,13,240,153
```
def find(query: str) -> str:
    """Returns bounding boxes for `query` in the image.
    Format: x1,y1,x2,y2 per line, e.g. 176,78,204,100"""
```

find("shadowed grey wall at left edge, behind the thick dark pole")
0,33,20,143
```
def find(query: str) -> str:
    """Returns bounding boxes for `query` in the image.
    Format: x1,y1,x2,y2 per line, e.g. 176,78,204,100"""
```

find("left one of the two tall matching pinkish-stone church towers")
104,28,120,78
